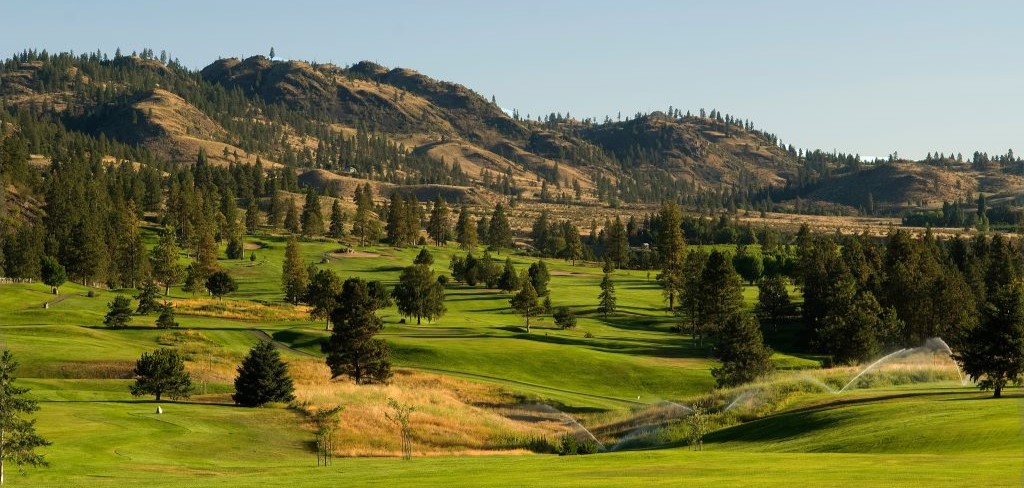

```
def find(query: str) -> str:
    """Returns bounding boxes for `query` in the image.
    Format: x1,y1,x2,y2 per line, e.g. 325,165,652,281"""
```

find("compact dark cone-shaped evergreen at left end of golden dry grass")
231,342,295,407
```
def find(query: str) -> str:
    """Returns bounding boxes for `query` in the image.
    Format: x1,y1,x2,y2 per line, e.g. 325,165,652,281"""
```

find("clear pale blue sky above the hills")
0,0,1024,157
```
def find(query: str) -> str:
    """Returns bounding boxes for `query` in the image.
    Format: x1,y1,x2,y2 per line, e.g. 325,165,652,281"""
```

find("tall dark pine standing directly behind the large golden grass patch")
323,278,391,384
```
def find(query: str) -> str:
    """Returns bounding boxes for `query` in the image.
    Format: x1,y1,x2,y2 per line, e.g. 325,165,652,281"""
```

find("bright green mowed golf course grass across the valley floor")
0,231,1024,487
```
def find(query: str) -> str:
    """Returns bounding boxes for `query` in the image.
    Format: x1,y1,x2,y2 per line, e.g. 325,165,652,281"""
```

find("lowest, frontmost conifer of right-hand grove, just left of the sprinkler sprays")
711,312,773,388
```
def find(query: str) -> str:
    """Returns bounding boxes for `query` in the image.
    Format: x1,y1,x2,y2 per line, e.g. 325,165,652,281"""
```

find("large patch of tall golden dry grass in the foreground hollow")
289,359,567,456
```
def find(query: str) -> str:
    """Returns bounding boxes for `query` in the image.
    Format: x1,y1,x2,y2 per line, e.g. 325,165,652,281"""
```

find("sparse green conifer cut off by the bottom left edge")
0,349,50,485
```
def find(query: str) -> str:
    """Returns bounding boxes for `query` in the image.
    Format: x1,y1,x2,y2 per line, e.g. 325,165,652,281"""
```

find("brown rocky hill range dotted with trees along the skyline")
0,50,1022,222
